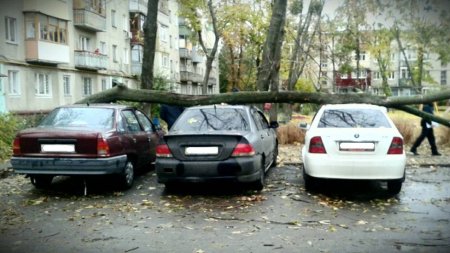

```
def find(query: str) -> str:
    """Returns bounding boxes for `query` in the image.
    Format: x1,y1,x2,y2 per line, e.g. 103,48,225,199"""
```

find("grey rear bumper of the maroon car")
11,155,127,175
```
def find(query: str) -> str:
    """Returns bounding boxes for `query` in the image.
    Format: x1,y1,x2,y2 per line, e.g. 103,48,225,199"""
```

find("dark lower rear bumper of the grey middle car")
155,157,261,183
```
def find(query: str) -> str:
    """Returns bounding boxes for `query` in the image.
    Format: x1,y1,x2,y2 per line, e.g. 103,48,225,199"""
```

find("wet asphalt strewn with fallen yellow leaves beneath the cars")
0,161,450,253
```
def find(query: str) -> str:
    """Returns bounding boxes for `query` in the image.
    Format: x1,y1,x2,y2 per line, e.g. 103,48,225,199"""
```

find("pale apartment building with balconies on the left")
0,0,219,113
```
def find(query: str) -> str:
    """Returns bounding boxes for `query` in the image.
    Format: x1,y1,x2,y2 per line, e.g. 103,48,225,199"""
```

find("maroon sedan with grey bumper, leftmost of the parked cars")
11,104,162,189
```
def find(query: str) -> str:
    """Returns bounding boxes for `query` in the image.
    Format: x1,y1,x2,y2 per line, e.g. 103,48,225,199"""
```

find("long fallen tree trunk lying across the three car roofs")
76,85,450,127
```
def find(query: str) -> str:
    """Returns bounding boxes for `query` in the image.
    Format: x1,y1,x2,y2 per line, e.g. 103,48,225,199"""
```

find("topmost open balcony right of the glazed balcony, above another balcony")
73,9,106,32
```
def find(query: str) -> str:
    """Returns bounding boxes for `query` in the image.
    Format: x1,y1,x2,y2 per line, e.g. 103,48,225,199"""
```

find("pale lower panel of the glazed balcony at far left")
25,40,70,65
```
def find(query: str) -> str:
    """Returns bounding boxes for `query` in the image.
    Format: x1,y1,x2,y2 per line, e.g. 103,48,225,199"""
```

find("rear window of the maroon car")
39,107,114,130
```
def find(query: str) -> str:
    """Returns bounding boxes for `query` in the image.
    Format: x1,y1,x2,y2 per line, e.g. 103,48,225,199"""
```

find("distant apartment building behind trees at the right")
318,42,450,96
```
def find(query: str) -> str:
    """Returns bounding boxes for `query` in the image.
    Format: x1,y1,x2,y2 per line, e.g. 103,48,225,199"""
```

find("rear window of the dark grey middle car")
173,108,250,131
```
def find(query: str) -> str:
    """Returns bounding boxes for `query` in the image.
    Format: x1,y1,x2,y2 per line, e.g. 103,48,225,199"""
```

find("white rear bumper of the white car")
303,154,406,180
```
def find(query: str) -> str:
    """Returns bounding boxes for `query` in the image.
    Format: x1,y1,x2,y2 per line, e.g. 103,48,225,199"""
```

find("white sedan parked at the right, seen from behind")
301,104,406,194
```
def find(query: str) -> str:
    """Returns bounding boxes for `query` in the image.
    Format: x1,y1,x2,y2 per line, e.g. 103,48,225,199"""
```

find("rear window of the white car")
318,109,391,128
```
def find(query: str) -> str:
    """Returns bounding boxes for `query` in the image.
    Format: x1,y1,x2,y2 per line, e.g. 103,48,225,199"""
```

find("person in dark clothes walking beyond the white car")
410,103,441,156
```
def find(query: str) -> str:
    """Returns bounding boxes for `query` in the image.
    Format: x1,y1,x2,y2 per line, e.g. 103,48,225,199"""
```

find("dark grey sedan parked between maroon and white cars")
155,105,278,190
